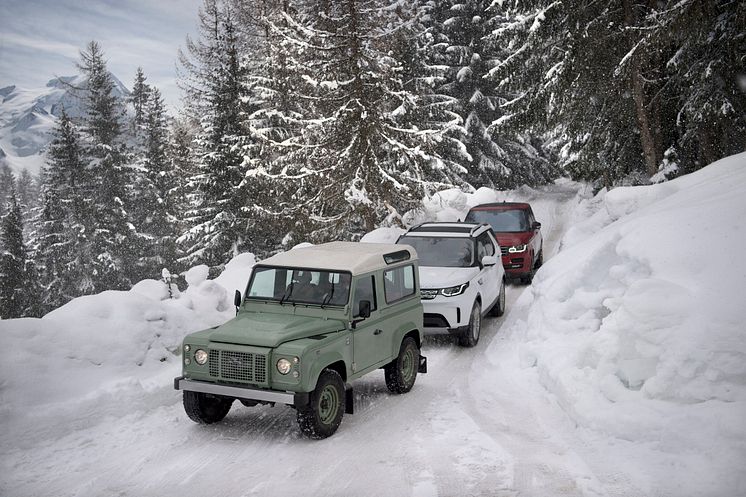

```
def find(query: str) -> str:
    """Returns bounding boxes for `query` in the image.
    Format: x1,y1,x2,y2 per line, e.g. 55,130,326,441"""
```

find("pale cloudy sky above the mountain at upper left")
0,0,202,110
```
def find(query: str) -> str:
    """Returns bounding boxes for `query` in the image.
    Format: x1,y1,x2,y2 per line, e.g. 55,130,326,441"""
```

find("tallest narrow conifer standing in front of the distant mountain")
78,41,137,291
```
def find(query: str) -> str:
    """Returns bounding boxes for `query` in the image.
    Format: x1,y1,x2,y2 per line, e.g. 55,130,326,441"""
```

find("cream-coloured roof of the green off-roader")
260,242,417,274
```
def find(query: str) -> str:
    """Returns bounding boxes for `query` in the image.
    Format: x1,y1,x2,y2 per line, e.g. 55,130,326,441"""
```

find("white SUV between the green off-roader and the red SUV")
396,223,505,347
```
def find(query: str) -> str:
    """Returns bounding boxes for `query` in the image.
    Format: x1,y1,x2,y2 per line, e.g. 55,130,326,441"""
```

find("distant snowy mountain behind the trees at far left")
0,75,129,174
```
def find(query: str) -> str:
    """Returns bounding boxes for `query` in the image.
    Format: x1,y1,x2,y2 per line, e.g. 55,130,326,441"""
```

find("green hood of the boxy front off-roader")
209,312,345,347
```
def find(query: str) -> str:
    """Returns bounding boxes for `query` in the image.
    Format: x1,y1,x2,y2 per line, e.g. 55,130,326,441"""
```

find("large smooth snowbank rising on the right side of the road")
502,154,746,495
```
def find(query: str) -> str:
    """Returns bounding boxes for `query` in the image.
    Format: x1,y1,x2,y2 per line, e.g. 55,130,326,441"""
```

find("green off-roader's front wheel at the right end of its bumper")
298,369,345,439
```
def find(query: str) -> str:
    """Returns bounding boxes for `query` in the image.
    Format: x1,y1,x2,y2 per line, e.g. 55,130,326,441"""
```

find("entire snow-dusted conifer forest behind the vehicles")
0,0,746,319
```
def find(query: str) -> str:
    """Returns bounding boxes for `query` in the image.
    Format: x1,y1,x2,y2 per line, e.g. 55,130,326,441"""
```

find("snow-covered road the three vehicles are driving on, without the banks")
0,182,604,497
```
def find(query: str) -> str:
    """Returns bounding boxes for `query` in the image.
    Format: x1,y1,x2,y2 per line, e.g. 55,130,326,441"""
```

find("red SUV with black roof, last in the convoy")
465,202,544,283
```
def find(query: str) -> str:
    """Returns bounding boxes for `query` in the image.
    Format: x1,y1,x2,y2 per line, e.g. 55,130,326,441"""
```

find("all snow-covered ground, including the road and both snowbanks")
0,154,746,497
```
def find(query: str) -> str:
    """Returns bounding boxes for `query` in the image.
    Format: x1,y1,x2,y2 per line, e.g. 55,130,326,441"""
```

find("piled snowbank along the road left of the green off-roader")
0,254,255,426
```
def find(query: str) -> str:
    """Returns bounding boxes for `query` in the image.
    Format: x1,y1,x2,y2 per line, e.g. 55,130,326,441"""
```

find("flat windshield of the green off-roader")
246,266,351,306
